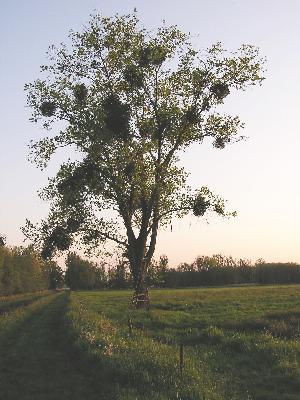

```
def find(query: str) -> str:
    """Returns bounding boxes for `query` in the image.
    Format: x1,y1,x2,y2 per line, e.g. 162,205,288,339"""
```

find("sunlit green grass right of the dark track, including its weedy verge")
72,285,300,400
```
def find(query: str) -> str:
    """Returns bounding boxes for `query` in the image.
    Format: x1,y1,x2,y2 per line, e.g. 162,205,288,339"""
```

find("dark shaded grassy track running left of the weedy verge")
0,293,113,400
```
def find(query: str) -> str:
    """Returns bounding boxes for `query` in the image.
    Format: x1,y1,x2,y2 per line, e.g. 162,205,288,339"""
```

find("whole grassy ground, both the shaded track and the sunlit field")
0,285,300,400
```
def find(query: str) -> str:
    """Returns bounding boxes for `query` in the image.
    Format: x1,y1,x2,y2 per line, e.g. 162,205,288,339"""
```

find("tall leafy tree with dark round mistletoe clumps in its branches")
24,13,263,306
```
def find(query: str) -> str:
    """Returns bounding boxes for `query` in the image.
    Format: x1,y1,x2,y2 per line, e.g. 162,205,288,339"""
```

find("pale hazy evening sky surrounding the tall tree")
0,0,300,266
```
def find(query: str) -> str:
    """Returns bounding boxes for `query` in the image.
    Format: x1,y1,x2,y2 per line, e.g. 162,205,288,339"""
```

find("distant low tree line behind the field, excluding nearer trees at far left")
65,253,300,289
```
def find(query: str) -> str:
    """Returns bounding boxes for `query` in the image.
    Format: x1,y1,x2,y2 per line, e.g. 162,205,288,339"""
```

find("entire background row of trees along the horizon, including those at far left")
0,234,300,296
